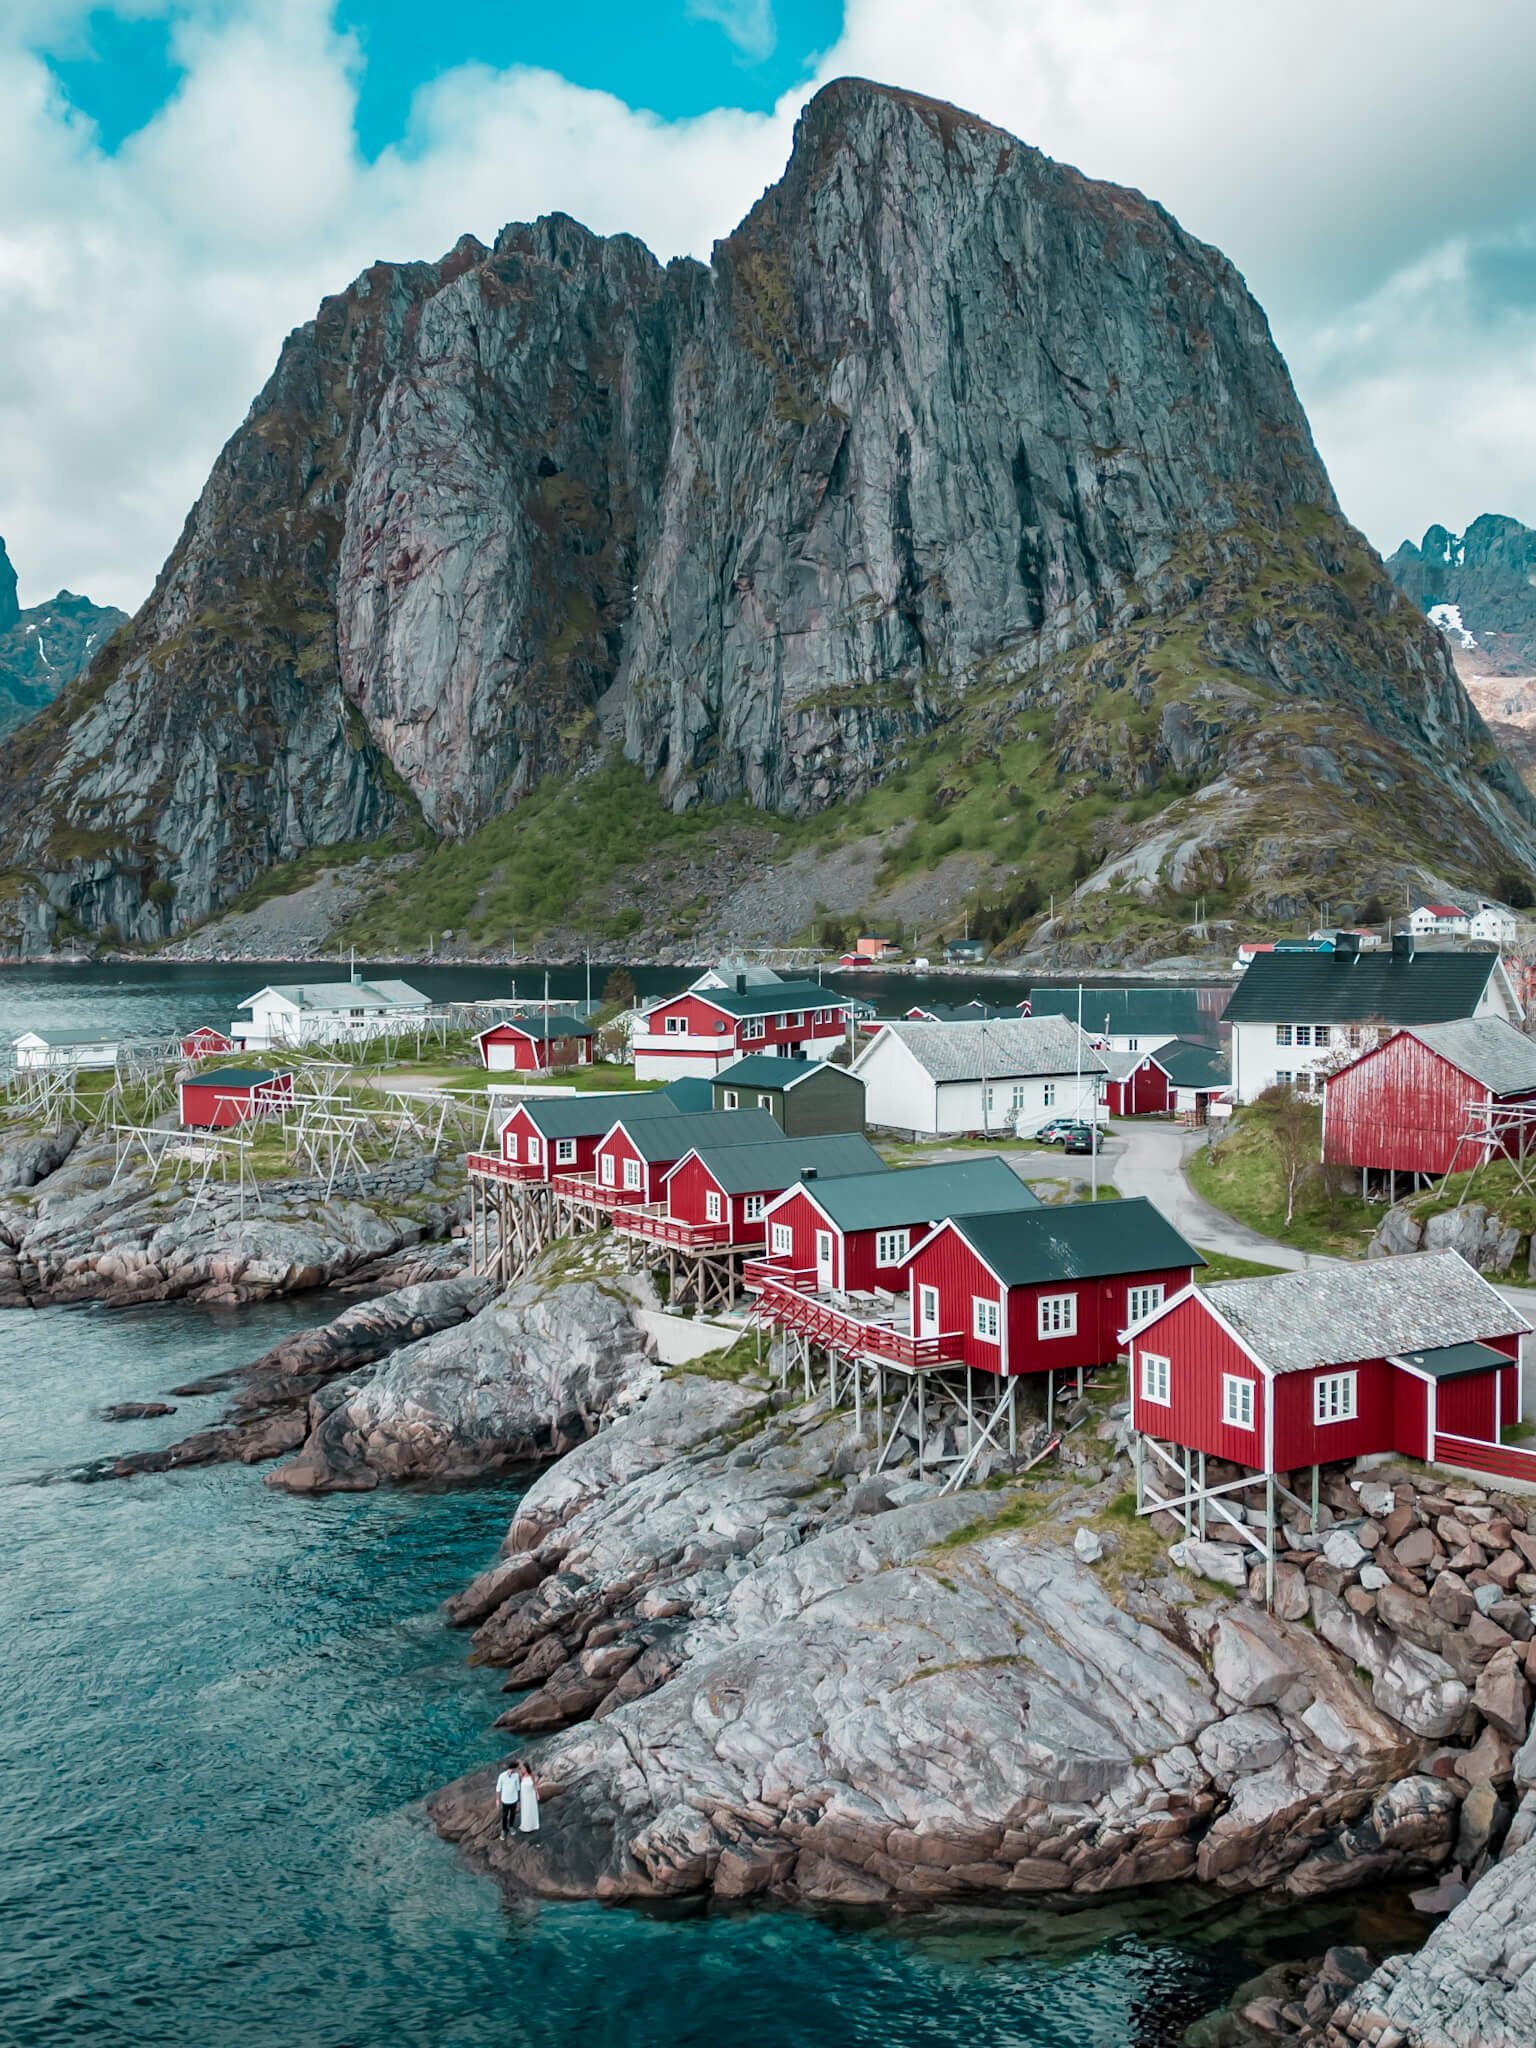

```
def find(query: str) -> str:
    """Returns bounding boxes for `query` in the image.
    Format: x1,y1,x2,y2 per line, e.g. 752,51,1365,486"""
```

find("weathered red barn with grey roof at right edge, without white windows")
1323,1018,1536,1178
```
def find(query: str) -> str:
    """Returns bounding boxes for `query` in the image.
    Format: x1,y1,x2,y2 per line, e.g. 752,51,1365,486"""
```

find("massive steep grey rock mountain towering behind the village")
0,80,1536,942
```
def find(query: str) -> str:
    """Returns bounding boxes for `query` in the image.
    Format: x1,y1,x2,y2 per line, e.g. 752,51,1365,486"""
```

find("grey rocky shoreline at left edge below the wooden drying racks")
0,1133,465,1307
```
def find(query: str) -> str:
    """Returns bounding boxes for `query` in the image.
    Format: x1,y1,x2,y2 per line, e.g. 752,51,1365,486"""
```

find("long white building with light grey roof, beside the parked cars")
852,1016,1104,1137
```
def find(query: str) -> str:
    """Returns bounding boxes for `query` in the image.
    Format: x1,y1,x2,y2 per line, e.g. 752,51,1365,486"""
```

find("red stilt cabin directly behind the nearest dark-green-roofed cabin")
766,1155,1040,1292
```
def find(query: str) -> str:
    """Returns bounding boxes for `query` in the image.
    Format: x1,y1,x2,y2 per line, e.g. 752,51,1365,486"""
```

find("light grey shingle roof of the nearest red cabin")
1200,1251,1530,1372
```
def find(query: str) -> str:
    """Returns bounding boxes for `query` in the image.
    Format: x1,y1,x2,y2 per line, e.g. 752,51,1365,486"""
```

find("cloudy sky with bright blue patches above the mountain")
0,0,1536,610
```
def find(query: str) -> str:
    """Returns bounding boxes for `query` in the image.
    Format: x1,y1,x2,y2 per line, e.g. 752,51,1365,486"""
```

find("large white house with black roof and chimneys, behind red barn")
1225,934,1522,1102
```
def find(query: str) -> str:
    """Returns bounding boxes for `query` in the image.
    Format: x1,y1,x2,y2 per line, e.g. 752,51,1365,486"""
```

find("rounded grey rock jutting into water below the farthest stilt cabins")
266,1280,655,1493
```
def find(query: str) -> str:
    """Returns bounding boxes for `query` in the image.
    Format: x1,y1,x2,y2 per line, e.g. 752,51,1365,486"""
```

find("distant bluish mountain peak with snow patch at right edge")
1386,512,1536,676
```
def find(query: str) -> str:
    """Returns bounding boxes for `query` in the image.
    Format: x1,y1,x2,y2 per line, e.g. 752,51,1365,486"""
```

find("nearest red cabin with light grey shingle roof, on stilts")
1128,1251,1536,1477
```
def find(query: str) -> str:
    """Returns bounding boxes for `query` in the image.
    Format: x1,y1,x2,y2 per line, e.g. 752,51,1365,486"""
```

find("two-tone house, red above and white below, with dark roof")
631,975,848,1081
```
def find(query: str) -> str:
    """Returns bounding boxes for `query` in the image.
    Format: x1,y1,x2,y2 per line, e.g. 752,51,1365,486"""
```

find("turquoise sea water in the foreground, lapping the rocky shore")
0,1303,1339,2048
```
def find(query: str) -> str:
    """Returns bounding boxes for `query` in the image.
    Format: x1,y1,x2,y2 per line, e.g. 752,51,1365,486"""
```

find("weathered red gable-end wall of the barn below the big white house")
1323,1032,1532,1174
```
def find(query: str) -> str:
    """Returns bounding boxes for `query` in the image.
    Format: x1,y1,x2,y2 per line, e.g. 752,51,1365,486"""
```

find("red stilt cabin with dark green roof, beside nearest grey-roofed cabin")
907,1198,1204,1374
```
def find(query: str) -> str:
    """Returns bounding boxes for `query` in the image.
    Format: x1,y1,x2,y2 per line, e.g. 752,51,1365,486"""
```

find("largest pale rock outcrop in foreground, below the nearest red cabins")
432,1374,1530,1905
